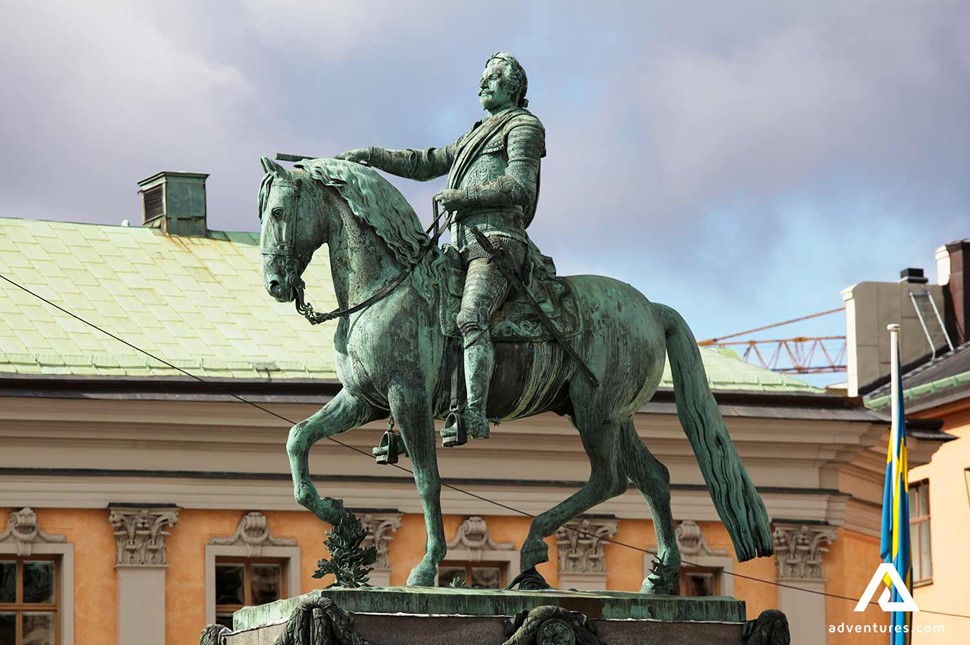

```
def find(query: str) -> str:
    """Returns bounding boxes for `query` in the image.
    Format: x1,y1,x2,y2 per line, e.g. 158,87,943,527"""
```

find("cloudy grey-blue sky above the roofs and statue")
0,0,970,378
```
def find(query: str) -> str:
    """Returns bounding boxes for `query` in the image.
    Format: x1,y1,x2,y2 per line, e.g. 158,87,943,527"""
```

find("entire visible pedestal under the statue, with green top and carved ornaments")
203,587,787,645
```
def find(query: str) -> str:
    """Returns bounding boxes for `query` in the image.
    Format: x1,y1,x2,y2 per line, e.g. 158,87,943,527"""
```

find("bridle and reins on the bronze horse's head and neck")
259,179,454,325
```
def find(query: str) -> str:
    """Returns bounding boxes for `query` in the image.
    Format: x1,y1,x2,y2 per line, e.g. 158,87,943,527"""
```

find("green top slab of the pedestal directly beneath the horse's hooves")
233,587,745,630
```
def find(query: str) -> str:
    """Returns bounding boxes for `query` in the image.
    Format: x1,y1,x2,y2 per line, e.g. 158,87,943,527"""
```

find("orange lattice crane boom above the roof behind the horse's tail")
697,308,846,374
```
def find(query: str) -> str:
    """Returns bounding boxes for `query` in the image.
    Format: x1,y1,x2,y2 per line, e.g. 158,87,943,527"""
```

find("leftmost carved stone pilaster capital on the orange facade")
108,506,179,567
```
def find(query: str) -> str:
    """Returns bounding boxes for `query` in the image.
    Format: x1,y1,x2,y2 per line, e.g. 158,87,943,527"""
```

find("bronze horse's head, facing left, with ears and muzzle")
259,157,323,302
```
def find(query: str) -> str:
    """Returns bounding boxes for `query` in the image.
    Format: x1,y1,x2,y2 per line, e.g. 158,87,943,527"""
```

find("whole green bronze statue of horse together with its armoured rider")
259,54,772,593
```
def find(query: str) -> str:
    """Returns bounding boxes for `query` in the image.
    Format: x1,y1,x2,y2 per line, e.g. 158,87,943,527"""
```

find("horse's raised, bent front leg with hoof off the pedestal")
286,390,378,524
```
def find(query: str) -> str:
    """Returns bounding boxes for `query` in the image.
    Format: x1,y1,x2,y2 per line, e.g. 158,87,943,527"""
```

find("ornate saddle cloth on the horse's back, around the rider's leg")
438,246,583,343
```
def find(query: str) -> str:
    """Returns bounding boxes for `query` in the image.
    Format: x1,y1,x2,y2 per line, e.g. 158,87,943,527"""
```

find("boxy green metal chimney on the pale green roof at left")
138,171,209,237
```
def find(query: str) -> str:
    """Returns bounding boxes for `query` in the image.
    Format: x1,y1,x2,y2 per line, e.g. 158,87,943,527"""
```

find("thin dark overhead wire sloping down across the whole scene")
0,273,970,618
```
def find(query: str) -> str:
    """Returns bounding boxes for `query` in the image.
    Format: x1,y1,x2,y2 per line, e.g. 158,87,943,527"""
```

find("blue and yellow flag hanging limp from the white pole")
880,343,913,645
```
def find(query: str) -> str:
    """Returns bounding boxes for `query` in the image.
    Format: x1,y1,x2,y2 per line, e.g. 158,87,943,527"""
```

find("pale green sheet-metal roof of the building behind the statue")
0,218,822,393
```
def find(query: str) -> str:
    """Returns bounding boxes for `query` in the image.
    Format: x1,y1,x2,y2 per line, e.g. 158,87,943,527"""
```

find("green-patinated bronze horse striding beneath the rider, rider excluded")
259,157,772,593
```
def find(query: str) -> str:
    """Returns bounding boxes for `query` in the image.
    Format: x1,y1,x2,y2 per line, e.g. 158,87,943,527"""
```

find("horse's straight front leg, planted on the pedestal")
388,386,448,587
